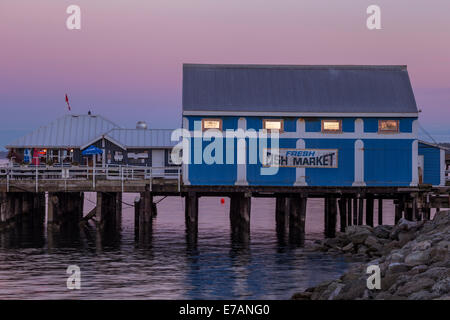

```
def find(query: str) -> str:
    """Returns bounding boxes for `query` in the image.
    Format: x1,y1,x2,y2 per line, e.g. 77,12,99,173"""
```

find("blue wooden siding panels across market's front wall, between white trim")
188,116,414,186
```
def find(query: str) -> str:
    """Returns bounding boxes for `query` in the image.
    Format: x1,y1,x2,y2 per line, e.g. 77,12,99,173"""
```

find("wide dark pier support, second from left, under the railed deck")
47,192,84,225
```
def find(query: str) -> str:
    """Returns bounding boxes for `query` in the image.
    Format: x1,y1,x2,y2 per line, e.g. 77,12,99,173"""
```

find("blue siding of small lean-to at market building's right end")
419,143,441,185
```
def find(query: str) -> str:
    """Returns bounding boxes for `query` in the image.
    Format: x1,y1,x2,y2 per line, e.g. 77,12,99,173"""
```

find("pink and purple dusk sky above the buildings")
0,0,450,149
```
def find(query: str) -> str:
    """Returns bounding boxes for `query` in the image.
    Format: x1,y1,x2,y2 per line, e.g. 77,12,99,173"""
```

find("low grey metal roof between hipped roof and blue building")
104,129,177,148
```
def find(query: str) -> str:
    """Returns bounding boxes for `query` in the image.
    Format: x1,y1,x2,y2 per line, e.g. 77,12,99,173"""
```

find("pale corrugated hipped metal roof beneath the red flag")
6,115,119,148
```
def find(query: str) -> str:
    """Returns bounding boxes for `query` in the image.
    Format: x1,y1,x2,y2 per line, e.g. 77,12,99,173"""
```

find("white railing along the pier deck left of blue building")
0,165,181,192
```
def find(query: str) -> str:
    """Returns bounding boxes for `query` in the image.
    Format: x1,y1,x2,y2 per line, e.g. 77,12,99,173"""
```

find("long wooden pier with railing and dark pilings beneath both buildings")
0,167,450,243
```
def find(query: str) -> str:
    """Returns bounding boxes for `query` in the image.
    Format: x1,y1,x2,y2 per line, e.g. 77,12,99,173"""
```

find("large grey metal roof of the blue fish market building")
183,64,417,113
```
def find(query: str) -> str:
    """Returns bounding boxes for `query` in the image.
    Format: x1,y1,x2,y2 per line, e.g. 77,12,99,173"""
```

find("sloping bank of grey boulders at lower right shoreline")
292,211,450,300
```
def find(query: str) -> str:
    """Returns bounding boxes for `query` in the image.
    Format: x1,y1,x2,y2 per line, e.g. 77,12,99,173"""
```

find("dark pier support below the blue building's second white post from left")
230,193,252,241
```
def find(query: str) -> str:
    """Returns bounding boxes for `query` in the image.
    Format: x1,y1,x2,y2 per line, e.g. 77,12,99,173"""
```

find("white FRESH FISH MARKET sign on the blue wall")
263,148,338,168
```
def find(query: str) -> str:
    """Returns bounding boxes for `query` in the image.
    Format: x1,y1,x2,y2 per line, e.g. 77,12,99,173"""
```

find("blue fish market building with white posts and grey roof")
183,64,445,187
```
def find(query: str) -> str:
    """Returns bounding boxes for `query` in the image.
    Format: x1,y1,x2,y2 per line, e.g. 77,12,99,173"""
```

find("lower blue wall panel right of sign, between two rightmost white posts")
363,139,414,186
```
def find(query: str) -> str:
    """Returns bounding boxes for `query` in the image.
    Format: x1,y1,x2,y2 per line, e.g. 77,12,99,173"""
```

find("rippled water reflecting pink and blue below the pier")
0,194,392,299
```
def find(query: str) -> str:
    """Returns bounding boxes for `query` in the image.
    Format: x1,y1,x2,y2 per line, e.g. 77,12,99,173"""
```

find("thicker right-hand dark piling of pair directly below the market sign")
289,194,308,244
